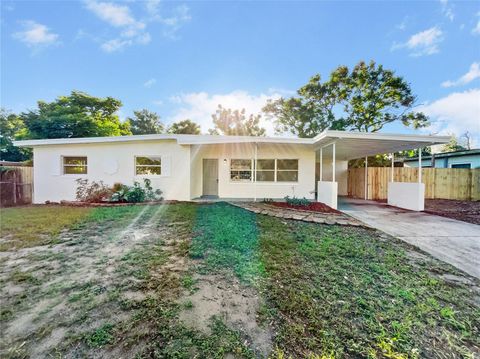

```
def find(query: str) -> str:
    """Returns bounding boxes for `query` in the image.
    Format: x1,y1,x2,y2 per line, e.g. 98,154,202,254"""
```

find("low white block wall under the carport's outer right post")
387,182,425,211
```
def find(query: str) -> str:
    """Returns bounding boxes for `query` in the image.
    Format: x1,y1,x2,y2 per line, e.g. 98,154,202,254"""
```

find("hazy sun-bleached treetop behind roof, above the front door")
209,105,266,136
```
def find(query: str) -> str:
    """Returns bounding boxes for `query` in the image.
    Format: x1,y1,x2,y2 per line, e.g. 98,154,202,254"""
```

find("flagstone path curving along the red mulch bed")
229,202,367,227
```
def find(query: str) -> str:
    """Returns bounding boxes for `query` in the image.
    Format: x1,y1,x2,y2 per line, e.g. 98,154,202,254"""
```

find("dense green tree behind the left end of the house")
20,91,131,139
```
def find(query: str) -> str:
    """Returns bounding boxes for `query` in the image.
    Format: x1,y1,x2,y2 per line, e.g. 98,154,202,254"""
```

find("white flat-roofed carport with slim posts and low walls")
313,131,450,211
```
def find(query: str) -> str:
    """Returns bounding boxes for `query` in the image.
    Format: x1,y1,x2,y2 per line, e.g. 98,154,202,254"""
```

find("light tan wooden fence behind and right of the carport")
348,167,480,201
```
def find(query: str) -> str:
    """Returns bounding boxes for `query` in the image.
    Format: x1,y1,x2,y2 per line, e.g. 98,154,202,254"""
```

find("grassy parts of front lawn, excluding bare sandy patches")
0,203,480,359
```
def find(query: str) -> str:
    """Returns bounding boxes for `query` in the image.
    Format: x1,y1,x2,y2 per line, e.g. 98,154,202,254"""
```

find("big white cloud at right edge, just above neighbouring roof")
418,88,480,146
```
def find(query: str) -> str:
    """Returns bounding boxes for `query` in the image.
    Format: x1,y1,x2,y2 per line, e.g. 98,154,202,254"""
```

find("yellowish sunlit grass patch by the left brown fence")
0,206,92,251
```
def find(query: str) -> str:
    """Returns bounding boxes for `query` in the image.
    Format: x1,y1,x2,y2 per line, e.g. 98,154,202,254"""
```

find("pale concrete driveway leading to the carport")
338,198,480,278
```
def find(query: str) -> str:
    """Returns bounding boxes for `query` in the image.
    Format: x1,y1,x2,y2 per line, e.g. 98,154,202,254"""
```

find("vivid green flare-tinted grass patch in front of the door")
190,203,263,283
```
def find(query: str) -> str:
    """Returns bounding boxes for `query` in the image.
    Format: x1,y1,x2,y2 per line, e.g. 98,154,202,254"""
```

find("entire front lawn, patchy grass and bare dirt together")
0,203,480,358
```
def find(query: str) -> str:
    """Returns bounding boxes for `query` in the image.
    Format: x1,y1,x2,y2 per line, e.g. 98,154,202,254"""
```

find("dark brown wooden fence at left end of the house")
0,166,33,207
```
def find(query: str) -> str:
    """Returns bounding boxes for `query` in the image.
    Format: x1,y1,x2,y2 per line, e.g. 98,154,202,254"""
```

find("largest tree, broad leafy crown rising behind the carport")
263,61,428,137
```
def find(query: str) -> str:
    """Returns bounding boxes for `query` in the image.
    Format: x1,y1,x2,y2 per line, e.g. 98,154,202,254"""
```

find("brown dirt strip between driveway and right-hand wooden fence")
425,199,480,224
